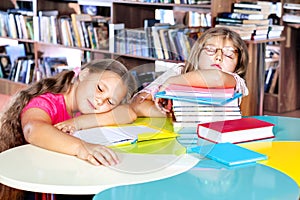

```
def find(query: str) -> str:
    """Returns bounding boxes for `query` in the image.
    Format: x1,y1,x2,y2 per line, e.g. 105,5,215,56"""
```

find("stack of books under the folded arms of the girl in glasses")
156,84,241,132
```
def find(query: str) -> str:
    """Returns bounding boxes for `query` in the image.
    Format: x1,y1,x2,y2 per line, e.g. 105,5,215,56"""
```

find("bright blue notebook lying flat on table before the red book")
190,142,268,167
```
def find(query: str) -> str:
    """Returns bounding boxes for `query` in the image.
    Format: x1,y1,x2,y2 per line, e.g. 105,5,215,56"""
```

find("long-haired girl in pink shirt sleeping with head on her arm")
0,59,136,169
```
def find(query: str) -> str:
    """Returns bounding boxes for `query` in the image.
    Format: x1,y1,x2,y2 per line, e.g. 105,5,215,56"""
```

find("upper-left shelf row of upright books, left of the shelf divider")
0,10,109,49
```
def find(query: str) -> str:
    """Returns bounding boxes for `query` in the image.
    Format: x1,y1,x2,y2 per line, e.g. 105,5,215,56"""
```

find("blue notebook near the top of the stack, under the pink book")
155,91,242,106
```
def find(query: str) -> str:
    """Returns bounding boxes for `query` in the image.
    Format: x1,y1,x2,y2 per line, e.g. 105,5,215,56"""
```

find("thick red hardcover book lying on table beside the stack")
197,118,274,143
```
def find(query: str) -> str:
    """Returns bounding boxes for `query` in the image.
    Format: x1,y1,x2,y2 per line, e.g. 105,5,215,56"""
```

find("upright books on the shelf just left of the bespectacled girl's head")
109,23,207,61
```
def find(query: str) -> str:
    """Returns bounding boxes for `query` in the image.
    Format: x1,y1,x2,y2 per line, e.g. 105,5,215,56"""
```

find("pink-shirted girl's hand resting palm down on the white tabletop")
77,141,119,166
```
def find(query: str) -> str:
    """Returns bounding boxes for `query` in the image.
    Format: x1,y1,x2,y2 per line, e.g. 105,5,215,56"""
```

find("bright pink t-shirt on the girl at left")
22,93,71,125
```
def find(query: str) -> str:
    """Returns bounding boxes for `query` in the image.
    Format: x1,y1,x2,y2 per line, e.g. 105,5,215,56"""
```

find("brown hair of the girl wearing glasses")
183,27,249,78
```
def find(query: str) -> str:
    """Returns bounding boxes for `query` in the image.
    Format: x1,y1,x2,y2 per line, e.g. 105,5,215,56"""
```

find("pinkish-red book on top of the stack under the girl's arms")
165,84,234,98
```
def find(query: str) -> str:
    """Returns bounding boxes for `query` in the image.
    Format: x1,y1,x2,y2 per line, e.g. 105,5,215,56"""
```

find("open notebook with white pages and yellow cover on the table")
74,125,179,146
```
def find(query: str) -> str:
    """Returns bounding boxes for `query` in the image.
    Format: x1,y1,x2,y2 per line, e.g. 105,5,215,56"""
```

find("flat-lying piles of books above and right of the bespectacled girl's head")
216,1,284,40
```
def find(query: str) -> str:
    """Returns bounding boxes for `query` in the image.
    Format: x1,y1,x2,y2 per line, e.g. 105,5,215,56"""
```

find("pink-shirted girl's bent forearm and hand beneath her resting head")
55,104,137,133
